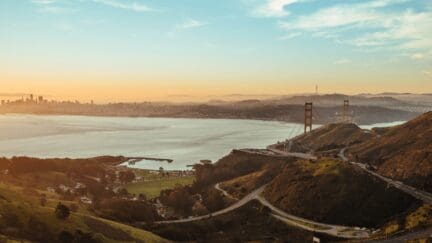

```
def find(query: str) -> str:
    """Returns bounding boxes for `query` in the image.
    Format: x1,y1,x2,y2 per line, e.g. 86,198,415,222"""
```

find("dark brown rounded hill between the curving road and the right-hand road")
264,159,419,227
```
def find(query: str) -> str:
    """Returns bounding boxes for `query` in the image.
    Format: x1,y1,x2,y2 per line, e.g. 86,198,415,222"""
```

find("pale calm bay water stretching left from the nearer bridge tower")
0,115,404,170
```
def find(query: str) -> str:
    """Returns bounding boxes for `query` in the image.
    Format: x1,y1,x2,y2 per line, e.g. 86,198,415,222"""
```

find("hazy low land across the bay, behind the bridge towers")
0,99,419,124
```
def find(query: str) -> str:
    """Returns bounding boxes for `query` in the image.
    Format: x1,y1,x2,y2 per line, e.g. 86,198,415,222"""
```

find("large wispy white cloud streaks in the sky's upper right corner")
279,0,432,60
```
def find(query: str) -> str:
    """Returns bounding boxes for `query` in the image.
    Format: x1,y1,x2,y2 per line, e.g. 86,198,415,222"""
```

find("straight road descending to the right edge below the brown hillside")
339,148,432,204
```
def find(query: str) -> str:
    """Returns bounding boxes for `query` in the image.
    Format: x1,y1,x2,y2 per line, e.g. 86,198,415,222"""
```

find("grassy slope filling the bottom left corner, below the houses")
0,184,168,242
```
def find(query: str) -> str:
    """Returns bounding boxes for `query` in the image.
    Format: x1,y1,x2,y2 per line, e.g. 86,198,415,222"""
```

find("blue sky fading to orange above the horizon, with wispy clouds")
0,0,432,102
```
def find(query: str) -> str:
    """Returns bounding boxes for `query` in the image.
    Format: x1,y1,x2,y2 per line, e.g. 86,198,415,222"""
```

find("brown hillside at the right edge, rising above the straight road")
349,112,432,191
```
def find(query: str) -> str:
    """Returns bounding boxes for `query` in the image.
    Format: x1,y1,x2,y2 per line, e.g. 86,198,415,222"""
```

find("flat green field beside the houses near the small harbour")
125,176,195,198
